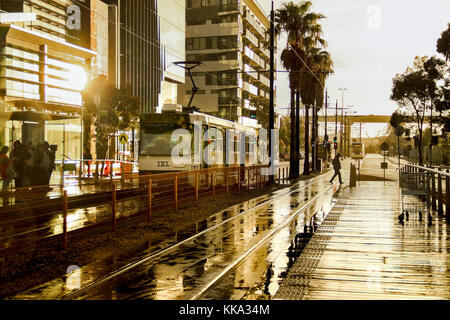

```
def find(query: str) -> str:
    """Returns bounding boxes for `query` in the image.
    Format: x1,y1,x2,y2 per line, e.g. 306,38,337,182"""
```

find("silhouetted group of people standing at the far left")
0,141,56,189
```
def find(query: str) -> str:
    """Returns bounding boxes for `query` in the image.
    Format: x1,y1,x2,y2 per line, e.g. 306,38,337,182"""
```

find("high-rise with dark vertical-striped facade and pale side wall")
105,0,186,113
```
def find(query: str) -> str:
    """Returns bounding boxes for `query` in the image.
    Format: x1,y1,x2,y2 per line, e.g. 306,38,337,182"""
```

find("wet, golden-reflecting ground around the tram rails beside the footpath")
10,165,338,300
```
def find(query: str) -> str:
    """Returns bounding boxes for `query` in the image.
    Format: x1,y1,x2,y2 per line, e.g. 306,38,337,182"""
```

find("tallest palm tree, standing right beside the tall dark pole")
275,1,324,178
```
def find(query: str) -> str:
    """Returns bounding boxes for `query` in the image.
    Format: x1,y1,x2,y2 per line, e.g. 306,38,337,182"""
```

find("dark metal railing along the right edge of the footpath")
401,163,450,222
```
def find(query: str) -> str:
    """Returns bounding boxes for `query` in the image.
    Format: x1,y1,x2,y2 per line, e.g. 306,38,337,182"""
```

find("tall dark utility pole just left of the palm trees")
269,1,275,184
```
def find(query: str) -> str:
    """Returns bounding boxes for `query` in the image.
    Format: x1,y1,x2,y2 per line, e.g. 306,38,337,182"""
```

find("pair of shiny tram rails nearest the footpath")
61,173,342,300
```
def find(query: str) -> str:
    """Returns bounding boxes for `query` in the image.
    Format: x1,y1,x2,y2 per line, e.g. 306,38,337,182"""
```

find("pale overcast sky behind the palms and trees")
258,0,450,136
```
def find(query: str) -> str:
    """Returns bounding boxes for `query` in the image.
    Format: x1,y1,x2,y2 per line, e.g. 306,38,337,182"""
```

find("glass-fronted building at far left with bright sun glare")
0,0,102,159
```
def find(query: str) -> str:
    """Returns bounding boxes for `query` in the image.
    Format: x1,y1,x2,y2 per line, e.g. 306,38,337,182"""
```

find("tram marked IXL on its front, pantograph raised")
139,107,261,174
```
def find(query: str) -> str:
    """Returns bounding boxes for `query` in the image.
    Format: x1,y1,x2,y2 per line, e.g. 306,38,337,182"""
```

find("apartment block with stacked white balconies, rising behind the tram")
180,0,270,125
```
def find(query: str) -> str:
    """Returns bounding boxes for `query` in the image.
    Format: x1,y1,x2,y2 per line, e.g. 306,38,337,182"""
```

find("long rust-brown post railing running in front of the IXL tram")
0,165,289,251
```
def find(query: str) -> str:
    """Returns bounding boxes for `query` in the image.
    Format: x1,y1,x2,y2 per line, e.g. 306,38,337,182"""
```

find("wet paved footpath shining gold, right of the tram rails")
274,156,450,300
